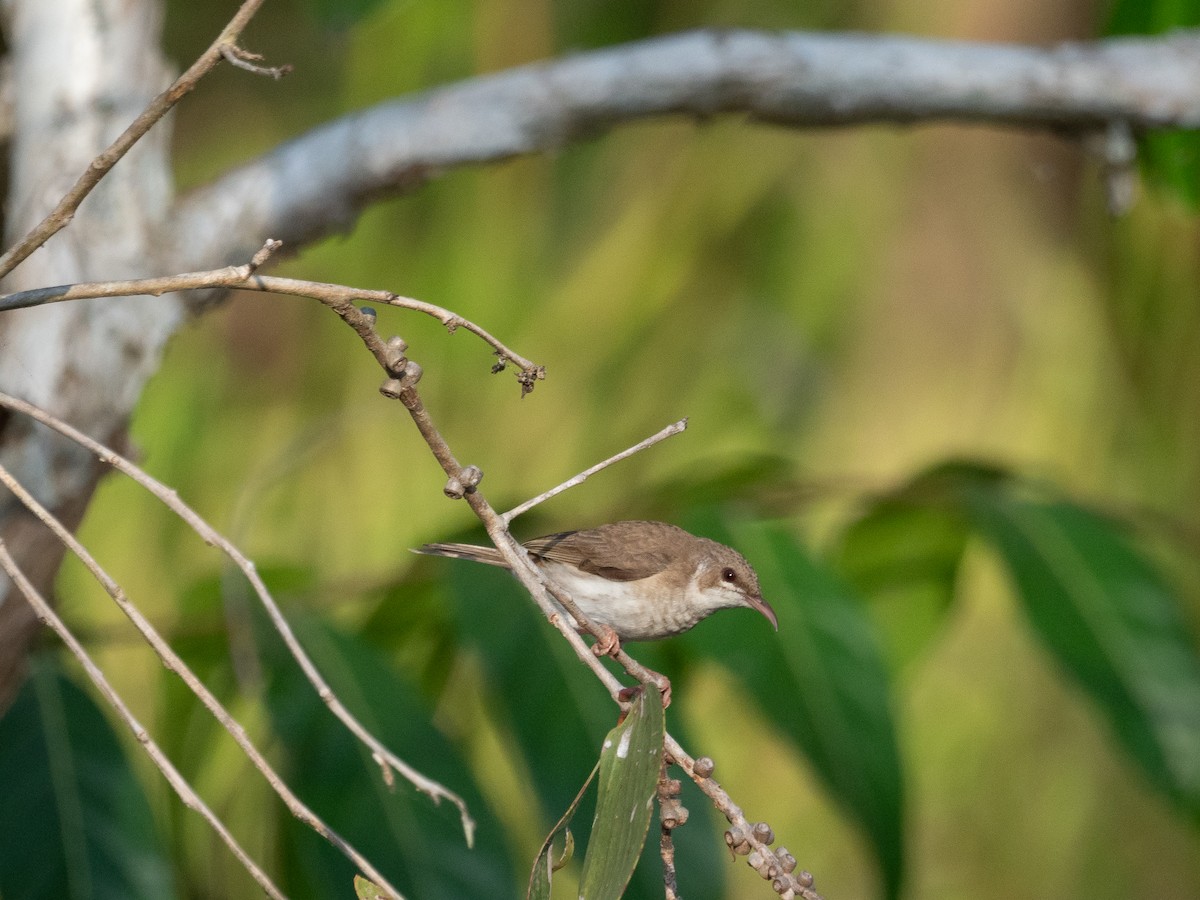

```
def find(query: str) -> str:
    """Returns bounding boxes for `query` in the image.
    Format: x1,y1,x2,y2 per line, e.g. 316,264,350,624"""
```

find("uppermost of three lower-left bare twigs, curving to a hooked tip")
0,392,475,845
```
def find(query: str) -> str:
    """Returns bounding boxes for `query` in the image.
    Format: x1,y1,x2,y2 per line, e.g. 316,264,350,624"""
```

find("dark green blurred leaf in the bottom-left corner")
0,658,175,900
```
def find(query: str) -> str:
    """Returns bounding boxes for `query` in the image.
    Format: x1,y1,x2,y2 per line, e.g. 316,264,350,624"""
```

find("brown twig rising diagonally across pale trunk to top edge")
0,0,278,277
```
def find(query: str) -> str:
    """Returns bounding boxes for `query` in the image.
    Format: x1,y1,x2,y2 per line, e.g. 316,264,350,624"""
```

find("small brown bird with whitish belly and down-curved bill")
413,521,779,655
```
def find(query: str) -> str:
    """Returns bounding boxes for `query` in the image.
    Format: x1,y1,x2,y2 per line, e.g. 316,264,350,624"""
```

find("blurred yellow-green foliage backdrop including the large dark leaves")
0,0,1200,899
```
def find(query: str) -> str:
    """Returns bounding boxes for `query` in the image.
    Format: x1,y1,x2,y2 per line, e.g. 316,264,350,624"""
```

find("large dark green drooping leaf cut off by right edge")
972,492,1200,816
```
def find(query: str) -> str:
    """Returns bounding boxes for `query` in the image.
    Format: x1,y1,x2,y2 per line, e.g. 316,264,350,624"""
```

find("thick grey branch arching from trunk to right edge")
166,30,1200,270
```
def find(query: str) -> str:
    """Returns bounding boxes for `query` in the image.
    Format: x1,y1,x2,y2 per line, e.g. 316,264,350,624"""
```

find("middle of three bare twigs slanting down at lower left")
0,465,401,900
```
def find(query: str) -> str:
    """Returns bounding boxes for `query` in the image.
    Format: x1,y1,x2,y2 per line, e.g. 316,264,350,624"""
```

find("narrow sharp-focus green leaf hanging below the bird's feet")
580,685,665,900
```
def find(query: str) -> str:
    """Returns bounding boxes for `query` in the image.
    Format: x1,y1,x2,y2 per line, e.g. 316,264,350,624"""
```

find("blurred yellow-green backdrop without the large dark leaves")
28,0,1200,900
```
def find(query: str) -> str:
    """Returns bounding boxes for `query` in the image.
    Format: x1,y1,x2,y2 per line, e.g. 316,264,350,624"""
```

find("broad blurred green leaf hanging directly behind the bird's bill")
685,524,904,898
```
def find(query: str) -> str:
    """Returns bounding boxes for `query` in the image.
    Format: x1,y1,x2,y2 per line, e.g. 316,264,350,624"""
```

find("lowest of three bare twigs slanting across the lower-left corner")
0,540,284,900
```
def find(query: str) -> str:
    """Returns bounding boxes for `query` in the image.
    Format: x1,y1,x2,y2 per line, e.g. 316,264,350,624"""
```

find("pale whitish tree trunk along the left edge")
0,0,181,707
